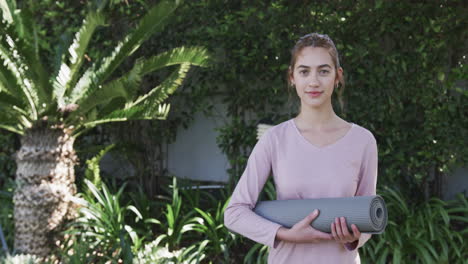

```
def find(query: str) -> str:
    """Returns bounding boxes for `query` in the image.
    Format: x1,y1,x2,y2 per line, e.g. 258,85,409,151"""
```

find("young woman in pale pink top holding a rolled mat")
224,33,377,264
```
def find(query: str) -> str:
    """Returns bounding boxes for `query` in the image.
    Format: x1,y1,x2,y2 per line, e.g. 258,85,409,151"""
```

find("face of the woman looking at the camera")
290,47,343,108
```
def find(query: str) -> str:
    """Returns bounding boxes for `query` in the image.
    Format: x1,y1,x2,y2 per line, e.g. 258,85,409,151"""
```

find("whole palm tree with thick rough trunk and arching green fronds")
0,0,208,256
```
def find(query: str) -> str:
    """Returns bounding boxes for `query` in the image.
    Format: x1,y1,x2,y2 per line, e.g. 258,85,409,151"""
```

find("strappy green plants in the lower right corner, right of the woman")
362,188,468,264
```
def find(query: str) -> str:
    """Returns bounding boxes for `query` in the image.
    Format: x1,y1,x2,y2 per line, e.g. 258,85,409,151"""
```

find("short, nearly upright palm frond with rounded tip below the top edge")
54,12,104,107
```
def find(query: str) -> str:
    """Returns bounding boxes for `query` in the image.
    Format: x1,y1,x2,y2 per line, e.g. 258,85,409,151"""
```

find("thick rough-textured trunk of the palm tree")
13,125,77,257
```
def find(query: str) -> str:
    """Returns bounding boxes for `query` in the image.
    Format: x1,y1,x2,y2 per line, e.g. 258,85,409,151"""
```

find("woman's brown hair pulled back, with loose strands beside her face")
287,33,345,112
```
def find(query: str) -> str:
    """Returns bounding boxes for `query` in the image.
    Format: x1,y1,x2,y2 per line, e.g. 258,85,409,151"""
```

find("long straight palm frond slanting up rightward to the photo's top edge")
67,1,177,106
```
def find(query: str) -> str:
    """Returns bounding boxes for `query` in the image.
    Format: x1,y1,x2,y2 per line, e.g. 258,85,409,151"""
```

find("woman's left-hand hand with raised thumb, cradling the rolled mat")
276,210,333,243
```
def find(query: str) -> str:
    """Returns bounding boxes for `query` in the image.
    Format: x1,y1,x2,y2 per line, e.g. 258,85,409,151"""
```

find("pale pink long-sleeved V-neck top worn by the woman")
224,119,378,264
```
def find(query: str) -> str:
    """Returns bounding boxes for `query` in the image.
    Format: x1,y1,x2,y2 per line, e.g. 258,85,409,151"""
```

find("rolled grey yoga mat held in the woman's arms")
254,195,388,234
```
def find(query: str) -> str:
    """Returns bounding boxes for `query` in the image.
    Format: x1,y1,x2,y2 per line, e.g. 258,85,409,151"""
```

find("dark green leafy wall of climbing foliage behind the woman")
1,0,468,202
